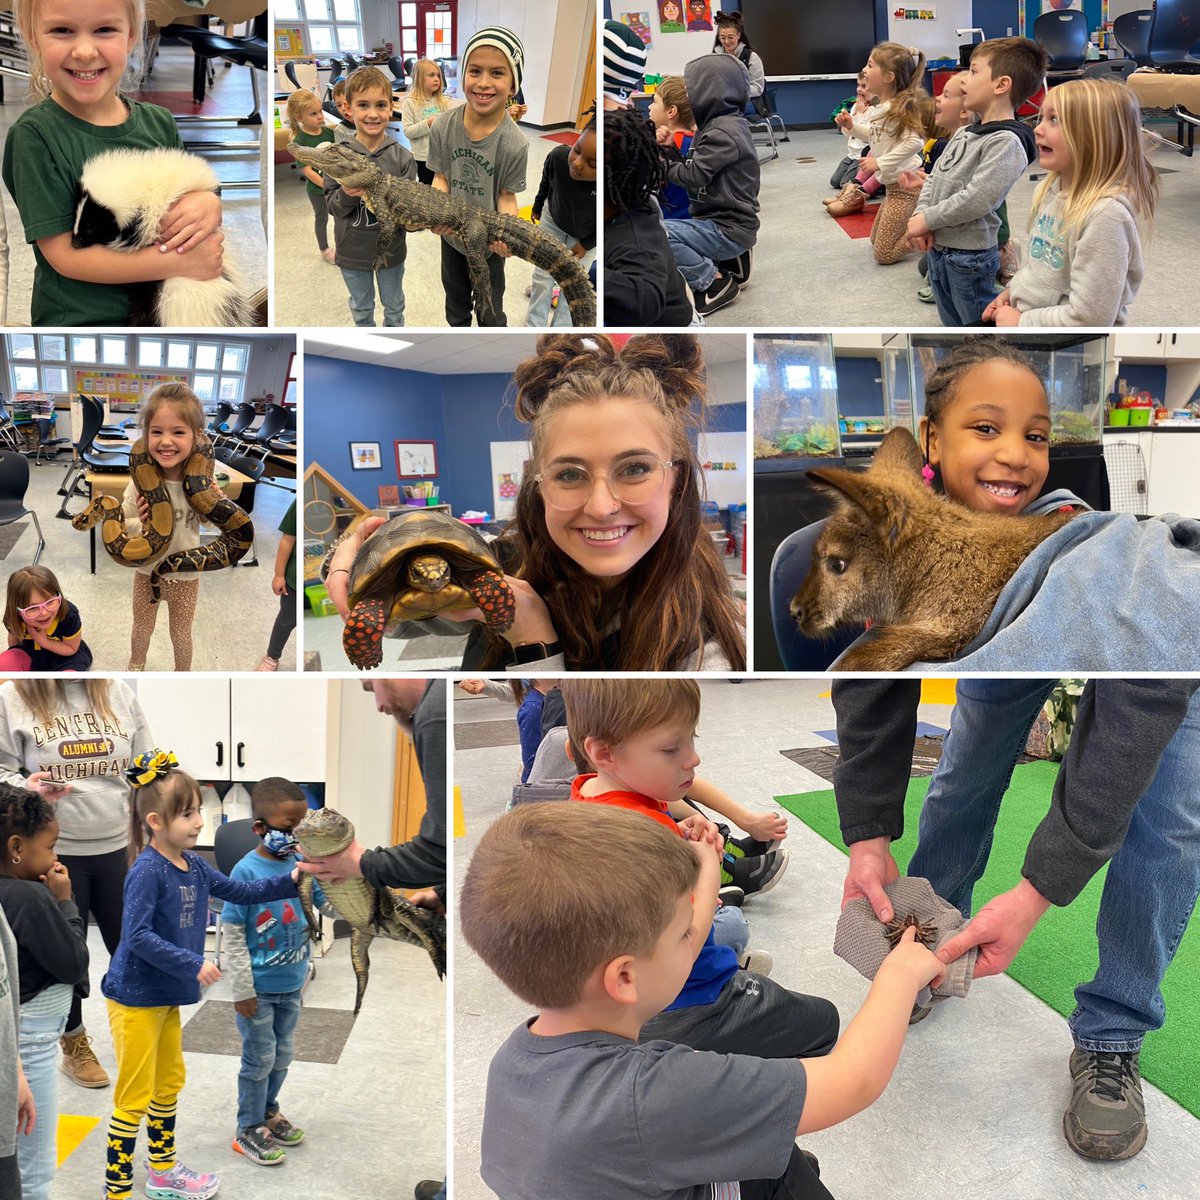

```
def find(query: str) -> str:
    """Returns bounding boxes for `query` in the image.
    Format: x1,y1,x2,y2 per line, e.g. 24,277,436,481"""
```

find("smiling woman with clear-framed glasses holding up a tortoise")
329,334,745,676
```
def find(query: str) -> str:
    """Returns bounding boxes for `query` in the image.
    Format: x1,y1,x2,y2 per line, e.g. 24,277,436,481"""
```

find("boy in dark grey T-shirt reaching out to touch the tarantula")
460,803,944,1200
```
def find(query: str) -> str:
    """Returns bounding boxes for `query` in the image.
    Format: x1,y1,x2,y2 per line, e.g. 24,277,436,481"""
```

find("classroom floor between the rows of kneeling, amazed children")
704,125,1200,329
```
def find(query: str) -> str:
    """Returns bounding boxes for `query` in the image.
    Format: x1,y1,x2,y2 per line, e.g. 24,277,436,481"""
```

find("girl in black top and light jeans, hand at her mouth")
0,784,88,1200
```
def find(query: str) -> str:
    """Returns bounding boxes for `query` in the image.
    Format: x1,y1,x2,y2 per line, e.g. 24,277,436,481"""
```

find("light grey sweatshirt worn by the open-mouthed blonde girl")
1008,187,1144,328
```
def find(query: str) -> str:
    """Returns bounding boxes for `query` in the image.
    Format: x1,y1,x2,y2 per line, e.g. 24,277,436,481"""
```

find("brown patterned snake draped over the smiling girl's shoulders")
71,437,254,602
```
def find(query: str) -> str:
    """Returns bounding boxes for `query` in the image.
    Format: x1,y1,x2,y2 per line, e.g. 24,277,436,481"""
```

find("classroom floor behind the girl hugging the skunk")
0,46,268,326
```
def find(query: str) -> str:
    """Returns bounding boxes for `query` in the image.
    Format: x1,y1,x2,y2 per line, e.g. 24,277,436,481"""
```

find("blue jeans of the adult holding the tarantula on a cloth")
907,679,1200,1051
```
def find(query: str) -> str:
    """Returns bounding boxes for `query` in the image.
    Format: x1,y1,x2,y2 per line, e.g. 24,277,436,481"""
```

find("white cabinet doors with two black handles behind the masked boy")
137,677,329,782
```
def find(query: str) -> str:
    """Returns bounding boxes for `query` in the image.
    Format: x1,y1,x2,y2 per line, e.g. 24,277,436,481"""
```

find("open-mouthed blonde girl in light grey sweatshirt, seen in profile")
983,79,1158,326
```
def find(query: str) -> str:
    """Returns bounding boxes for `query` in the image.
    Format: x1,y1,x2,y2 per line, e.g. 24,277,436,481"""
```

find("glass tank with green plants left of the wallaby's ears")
754,334,841,470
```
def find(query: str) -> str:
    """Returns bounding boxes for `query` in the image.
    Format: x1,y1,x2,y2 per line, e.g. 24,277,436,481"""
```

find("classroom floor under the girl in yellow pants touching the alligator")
50,923,446,1200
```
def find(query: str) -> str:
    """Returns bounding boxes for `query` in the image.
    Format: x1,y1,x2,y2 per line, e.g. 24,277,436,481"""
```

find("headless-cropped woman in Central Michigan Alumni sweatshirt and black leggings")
0,676,154,1087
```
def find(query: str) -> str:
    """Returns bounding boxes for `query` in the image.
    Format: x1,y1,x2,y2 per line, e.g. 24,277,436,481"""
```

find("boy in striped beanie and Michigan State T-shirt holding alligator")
427,25,529,325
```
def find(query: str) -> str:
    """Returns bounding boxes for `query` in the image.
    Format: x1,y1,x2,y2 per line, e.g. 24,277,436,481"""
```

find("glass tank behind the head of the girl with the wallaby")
908,334,1109,445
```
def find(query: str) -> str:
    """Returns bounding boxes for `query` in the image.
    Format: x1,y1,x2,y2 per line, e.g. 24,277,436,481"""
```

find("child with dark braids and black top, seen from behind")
604,108,703,328
